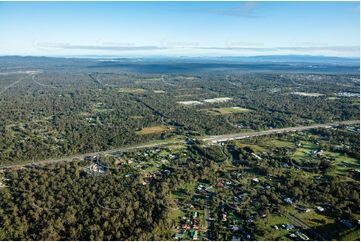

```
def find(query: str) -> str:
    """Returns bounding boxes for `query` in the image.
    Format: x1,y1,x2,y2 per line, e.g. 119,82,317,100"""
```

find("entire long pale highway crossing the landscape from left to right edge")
0,120,360,171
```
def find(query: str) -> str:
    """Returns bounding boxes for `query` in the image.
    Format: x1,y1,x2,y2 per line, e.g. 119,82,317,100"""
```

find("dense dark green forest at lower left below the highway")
0,142,214,240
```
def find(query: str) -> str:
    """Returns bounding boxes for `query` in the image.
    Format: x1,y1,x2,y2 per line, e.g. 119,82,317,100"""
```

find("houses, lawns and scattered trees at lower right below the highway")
173,127,360,240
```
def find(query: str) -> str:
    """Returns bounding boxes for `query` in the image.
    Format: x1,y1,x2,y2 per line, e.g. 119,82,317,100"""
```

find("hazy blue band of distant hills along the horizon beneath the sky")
0,55,360,74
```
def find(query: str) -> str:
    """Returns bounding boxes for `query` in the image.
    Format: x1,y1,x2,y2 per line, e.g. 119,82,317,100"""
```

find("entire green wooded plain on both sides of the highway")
0,57,360,240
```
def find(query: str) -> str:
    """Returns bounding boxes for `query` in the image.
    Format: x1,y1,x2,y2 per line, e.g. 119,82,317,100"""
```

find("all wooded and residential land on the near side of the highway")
0,126,360,240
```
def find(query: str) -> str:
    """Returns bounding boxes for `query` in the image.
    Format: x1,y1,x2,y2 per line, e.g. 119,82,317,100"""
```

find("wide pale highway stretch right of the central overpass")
202,120,360,144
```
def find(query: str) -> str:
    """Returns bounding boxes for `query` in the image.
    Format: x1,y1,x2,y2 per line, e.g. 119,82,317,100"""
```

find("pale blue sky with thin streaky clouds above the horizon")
0,2,360,57
